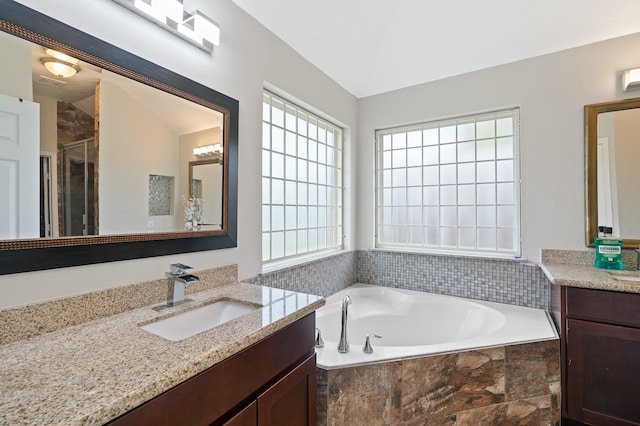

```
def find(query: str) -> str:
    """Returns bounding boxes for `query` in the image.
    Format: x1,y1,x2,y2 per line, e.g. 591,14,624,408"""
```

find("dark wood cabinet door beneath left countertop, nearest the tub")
258,354,316,426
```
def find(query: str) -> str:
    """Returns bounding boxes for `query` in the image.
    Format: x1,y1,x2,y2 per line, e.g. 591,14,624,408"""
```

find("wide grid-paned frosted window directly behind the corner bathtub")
376,109,520,257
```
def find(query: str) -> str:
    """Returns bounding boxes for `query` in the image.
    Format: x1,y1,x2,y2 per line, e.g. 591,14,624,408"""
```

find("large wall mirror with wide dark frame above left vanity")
0,0,238,274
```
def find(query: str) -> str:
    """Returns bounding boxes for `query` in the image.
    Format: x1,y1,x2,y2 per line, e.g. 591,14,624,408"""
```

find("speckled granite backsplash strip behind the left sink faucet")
0,264,238,344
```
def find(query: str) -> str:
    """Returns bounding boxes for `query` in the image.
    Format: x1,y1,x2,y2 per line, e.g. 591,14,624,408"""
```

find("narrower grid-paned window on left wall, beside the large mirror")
262,91,343,264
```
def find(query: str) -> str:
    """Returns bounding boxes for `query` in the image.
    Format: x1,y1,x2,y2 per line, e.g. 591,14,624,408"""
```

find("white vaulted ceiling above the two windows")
232,0,640,98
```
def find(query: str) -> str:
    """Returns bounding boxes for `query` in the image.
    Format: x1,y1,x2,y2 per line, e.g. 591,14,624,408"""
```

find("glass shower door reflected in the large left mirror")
61,139,95,236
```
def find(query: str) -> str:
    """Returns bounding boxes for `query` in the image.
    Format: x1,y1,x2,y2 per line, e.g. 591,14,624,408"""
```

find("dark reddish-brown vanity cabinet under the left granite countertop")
109,313,316,426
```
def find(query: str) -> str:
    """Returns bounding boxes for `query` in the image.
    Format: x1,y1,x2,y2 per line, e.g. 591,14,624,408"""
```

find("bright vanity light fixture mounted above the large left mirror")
113,0,220,53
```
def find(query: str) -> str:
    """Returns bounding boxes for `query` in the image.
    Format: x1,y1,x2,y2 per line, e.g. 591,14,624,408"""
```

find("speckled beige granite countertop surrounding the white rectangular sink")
0,283,324,425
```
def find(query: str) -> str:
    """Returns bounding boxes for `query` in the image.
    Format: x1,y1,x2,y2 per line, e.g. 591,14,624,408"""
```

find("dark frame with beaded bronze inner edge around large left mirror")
0,0,239,275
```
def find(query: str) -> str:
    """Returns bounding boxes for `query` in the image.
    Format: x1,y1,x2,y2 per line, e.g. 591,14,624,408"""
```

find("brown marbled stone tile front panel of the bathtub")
318,339,560,426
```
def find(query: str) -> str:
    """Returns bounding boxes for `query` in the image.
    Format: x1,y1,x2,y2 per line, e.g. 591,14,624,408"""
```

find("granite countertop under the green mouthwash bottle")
541,263,640,293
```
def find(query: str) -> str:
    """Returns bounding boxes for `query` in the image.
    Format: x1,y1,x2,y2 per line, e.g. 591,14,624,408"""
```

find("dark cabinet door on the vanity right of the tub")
566,319,640,425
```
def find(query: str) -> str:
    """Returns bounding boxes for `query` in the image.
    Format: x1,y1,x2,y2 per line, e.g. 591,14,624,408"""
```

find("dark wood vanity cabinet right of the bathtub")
554,287,640,425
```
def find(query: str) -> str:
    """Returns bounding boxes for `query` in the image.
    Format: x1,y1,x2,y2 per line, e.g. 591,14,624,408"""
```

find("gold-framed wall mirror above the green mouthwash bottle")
584,98,640,249
